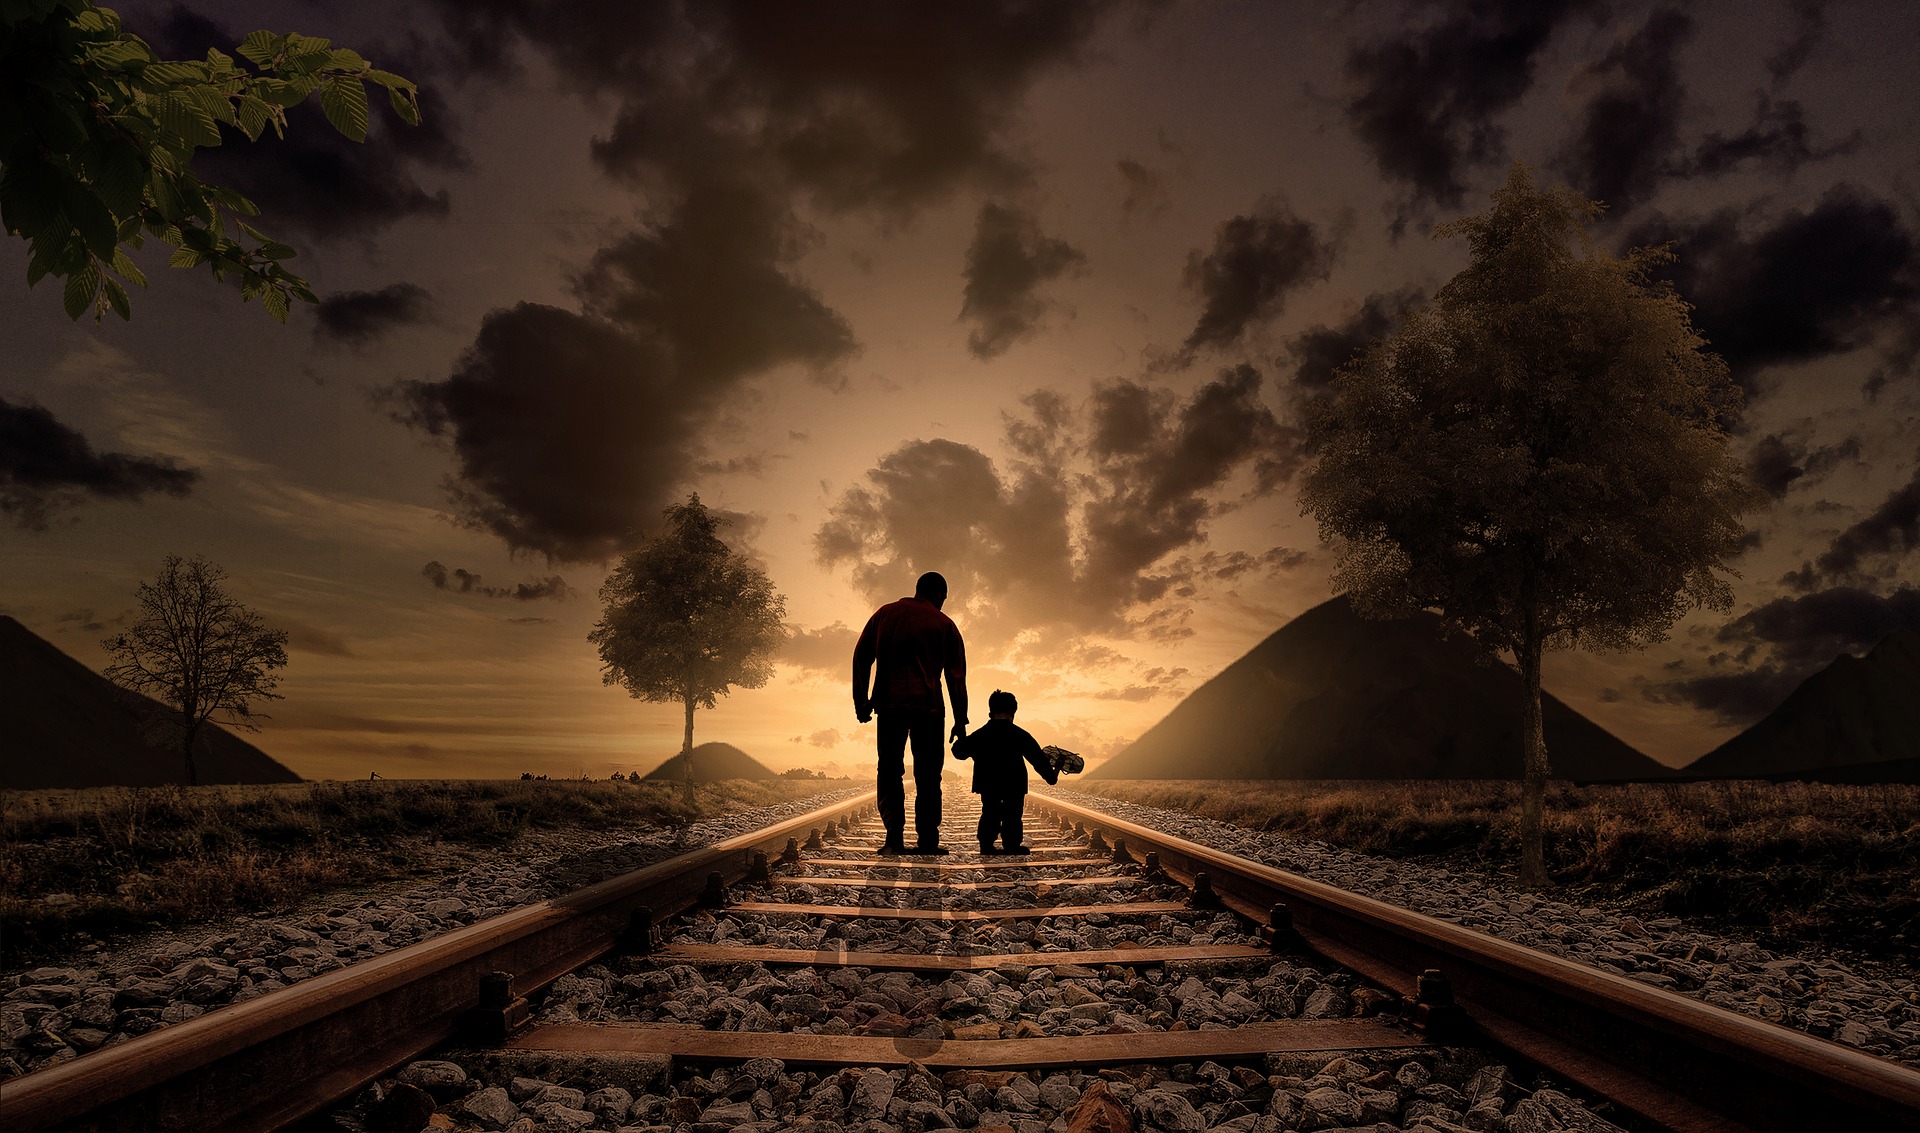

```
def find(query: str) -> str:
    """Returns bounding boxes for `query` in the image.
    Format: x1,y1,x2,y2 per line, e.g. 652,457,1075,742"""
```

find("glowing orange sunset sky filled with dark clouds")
0,0,1920,778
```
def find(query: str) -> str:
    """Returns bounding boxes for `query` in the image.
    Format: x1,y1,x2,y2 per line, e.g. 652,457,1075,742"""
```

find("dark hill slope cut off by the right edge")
1680,630,1920,783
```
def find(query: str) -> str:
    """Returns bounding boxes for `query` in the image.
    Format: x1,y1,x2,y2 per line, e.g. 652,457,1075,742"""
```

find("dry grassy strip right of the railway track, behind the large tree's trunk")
1073,780,1920,962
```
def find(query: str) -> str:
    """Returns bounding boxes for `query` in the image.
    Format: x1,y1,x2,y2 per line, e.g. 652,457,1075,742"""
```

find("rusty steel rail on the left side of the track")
0,791,874,1133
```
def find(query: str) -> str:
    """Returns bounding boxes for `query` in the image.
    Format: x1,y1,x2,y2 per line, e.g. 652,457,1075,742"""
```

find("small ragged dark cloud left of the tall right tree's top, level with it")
1181,202,1334,361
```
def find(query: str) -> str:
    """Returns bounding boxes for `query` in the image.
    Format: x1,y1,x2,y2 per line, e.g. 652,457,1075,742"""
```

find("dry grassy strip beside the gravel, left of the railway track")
0,780,849,968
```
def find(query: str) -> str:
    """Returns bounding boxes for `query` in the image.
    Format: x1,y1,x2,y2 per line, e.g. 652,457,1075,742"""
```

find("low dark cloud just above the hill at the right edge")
1644,586,1920,724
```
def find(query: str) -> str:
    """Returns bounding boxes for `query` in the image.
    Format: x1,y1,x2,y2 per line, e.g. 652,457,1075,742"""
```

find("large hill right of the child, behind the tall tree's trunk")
1089,597,1672,780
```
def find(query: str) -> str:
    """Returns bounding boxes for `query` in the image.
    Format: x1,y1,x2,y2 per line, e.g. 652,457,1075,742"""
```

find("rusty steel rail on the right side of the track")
1033,793,1920,1133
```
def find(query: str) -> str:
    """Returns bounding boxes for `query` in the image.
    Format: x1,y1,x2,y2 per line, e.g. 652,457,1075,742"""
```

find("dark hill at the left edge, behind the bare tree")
0,615,300,789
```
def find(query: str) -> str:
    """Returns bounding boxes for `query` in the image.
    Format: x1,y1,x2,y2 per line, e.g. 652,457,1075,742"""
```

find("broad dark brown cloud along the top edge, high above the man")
442,0,1123,215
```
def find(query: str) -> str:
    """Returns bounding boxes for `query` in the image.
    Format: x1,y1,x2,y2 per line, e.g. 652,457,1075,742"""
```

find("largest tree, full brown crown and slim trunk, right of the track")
1300,163,1761,885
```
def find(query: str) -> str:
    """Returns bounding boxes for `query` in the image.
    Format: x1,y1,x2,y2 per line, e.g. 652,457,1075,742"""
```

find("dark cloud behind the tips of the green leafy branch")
143,6,468,238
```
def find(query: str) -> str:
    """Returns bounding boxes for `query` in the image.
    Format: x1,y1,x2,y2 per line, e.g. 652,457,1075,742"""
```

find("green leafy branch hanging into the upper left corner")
0,0,420,323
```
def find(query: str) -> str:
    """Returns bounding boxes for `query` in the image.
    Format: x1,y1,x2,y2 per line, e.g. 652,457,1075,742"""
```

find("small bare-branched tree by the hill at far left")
102,555,286,785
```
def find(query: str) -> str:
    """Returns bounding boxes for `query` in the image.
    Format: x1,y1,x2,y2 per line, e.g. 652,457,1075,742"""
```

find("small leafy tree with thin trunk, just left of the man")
588,495,787,787
